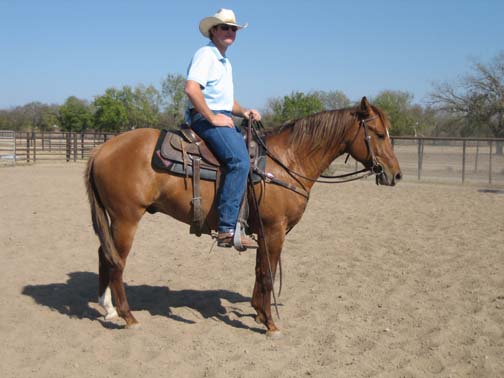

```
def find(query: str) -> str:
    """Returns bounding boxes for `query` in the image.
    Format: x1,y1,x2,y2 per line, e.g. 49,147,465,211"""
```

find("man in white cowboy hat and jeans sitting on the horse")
185,9,261,248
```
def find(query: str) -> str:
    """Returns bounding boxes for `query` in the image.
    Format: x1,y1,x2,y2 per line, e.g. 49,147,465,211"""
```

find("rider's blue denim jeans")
191,111,250,232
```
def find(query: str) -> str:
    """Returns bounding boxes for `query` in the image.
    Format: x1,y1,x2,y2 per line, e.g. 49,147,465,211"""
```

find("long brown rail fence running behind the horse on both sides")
0,130,504,185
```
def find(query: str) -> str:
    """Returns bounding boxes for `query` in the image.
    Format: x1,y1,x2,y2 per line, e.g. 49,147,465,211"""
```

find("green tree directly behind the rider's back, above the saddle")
161,74,186,126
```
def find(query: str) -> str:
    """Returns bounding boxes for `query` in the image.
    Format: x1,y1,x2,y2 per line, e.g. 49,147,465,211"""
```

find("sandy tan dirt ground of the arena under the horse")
0,163,504,378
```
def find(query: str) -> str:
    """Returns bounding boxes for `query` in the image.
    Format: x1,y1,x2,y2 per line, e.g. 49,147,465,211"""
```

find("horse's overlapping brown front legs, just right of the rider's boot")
252,229,285,336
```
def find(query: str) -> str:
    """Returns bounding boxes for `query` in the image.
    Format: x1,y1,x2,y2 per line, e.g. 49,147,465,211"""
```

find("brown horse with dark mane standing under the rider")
85,97,401,335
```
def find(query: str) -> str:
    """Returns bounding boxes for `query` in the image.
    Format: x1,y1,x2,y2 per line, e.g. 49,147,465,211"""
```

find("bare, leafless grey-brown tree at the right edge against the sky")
430,51,504,154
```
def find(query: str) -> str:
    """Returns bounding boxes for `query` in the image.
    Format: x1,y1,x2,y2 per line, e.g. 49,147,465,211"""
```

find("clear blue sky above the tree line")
0,0,504,109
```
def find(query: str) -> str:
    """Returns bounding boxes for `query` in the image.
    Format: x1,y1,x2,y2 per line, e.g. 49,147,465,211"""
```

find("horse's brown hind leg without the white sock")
104,221,138,327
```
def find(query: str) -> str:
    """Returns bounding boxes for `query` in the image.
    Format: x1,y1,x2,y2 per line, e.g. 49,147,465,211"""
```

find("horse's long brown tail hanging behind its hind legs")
84,147,123,268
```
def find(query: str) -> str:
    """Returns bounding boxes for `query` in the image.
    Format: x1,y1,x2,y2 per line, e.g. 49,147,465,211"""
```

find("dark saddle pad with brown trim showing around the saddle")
151,130,266,184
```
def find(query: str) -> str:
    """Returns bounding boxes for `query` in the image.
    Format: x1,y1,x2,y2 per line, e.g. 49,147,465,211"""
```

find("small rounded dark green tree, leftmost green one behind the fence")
58,96,93,132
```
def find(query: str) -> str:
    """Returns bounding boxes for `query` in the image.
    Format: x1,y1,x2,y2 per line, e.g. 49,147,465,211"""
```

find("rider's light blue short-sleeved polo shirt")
187,41,234,111
